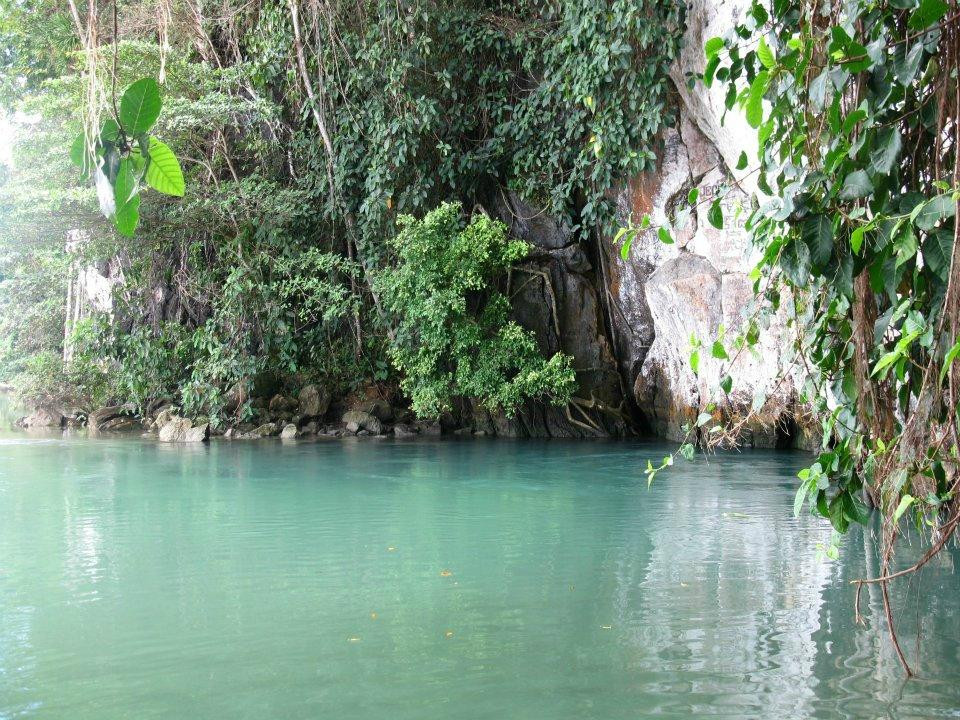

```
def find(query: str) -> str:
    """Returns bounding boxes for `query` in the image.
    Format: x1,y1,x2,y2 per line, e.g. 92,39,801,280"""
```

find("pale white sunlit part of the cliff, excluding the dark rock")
601,0,796,446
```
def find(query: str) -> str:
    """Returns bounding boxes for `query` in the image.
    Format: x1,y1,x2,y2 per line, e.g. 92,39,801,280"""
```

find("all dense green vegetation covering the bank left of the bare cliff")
0,0,681,417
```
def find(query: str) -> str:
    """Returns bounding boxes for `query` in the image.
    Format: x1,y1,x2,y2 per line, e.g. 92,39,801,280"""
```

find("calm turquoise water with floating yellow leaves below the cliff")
0,434,960,720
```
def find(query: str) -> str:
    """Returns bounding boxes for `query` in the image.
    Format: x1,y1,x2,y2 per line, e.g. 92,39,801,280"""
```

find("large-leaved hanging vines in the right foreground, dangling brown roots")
703,0,960,542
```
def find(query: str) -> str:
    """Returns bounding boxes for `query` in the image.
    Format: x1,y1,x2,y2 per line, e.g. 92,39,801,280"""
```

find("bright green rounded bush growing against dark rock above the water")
377,203,574,416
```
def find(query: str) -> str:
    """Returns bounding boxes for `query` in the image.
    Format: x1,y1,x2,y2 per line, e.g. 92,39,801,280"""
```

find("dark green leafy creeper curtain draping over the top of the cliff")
262,0,683,253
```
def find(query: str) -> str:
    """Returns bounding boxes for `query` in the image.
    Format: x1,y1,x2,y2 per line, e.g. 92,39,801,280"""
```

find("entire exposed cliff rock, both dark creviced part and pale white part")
488,0,796,446
